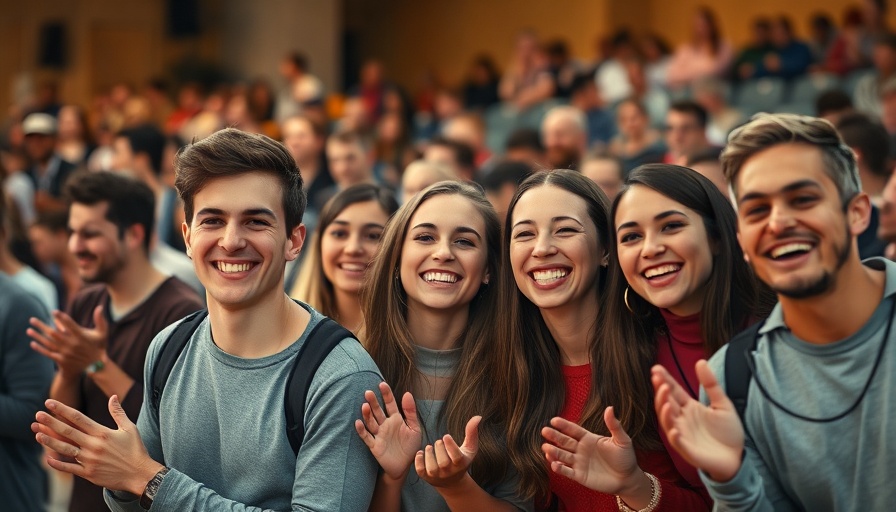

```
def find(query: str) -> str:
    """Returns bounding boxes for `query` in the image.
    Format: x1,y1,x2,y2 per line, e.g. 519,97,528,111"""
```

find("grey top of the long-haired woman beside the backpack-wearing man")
401,346,532,512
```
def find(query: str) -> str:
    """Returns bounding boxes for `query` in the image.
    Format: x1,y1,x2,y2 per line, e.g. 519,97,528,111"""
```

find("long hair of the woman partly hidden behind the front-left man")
293,183,398,321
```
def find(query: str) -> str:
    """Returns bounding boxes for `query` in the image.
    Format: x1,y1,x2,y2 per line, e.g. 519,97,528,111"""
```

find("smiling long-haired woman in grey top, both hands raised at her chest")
355,182,529,511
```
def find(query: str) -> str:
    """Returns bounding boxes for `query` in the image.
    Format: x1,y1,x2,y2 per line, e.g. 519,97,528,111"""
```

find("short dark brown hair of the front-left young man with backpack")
174,128,306,233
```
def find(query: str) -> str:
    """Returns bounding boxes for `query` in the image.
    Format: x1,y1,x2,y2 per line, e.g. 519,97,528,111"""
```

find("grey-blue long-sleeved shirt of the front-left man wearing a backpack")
106,303,382,512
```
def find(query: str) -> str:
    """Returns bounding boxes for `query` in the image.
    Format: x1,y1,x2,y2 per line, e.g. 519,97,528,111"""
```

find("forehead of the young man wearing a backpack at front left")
193,171,284,218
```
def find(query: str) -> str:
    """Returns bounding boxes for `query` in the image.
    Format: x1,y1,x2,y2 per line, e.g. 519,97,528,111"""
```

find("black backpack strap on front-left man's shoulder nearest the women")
284,317,357,456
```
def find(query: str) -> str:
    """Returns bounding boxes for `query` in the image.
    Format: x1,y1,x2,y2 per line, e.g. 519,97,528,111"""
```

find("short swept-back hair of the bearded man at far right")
721,114,862,206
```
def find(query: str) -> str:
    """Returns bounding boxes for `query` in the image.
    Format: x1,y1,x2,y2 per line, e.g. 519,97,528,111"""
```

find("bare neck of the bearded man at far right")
778,256,885,345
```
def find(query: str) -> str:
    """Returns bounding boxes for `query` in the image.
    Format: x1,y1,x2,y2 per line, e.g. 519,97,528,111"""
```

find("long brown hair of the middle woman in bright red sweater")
498,170,628,499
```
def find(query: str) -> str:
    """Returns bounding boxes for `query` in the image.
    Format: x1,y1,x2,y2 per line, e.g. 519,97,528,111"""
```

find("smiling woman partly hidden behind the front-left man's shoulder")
290,183,398,336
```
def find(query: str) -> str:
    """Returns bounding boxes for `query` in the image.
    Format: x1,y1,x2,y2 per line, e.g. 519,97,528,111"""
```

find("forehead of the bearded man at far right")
735,143,837,200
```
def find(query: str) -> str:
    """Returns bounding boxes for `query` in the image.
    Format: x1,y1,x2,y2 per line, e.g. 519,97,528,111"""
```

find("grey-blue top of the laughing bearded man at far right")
701,258,896,512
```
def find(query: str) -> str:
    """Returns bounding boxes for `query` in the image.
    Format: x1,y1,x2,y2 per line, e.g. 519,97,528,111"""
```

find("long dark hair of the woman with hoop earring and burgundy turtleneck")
592,164,774,396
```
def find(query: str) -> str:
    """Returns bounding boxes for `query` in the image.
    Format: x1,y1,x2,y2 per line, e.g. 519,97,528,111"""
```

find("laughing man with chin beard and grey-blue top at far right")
653,114,896,511
